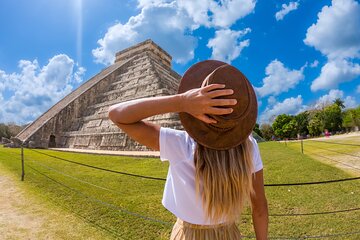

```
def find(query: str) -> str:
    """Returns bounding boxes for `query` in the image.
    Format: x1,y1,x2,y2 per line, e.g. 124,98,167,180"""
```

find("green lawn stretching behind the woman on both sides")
0,142,360,239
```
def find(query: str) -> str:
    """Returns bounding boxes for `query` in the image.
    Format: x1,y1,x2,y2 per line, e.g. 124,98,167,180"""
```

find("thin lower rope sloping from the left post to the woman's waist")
26,164,173,225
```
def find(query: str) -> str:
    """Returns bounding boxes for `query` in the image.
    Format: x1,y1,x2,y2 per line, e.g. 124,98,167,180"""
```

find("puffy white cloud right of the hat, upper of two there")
255,59,304,97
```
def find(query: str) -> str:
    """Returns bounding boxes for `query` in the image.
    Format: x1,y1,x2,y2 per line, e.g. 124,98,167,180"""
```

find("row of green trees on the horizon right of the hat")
254,98,360,140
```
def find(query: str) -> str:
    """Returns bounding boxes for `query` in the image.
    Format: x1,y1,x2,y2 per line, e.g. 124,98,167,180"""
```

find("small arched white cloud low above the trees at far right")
315,89,357,108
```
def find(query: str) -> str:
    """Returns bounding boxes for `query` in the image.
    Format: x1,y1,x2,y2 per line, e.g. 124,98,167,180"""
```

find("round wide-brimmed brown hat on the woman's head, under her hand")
178,60,257,150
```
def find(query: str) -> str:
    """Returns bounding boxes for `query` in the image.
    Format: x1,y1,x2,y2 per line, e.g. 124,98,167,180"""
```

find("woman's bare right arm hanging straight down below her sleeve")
251,170,269,240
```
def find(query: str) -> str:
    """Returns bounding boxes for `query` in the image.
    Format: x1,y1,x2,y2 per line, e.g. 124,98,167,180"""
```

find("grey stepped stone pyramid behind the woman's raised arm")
16,40,181,150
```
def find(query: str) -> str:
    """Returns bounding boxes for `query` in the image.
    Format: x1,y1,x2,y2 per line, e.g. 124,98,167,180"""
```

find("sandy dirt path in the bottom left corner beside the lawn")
0,165,108,240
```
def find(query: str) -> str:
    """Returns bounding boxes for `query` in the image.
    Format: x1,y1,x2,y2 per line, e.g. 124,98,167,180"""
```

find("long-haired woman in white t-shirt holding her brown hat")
109,60,268,240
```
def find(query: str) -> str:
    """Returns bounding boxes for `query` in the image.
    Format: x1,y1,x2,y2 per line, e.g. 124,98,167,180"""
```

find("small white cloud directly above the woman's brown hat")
207,28,251,63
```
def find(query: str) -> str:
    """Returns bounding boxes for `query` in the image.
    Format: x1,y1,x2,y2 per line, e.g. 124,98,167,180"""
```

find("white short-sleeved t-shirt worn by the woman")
159,127,263,225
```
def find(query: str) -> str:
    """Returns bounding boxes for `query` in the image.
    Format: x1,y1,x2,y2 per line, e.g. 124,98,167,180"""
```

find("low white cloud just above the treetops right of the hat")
259,95,305,123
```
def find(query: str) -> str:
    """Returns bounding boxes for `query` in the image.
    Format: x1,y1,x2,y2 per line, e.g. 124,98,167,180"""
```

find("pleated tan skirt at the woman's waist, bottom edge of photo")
170,218,241,240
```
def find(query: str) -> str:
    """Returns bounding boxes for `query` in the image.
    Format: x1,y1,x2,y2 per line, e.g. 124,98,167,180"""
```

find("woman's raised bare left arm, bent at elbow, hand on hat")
108,84,236,151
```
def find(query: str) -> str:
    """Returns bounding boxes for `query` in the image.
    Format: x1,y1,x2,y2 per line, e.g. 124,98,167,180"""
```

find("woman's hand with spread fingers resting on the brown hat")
181,84,237,123
